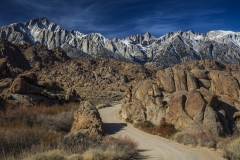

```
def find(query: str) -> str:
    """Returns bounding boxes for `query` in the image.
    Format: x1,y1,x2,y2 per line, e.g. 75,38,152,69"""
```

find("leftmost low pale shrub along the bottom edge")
33,149,67,160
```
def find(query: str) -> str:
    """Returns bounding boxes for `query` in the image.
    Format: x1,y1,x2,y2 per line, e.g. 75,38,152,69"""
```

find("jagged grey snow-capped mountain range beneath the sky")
0,17,240,67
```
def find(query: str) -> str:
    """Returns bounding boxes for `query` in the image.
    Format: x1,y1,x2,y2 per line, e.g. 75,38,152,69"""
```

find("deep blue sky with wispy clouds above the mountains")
0,0,240,38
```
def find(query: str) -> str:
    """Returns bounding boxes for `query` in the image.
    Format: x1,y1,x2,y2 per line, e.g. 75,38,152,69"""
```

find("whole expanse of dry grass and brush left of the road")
0,105,137,160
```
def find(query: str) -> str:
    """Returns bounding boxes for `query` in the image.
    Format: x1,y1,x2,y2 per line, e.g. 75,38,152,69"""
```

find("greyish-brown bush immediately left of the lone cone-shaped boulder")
38,109,75,132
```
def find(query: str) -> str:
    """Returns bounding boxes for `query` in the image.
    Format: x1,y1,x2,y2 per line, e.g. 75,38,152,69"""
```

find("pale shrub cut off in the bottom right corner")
226,137,240,160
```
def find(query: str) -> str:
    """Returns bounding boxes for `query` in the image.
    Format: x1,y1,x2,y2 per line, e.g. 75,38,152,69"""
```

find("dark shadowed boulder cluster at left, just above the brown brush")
6,72,79,105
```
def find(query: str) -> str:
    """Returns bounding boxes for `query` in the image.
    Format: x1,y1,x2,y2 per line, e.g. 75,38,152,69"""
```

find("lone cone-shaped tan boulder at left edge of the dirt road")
69,101,103,137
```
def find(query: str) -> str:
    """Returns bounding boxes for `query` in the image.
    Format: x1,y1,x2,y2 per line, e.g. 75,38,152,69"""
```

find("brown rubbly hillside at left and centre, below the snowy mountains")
0,39,155,105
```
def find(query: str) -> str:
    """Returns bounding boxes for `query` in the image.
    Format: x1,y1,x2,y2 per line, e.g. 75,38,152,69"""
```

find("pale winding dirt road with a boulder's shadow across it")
99,104,224,160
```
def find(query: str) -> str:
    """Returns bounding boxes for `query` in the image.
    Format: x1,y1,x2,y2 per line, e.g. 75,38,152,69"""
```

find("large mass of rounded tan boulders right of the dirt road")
121,64,240,136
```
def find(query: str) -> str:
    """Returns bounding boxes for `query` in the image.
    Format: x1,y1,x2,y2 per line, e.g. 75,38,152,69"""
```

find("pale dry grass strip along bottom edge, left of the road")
26,136,137,160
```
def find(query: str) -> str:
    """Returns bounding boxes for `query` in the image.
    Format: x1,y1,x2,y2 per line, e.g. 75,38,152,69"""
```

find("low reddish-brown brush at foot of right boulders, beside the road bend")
134,121,177,138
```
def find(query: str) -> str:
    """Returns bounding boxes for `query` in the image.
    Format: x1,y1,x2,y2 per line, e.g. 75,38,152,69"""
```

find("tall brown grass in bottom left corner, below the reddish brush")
0,123,62,158
